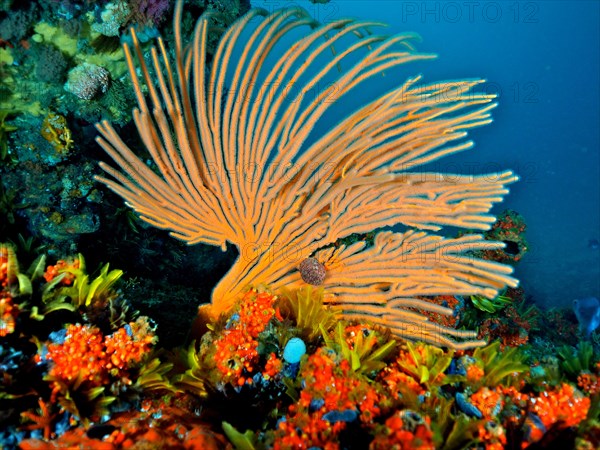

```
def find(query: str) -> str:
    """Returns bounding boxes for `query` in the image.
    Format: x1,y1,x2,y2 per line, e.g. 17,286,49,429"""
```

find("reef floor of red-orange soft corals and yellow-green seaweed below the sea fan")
0,244,600,450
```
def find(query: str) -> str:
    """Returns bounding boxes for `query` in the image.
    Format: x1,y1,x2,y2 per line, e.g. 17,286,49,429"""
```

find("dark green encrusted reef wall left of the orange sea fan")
0,0,247,256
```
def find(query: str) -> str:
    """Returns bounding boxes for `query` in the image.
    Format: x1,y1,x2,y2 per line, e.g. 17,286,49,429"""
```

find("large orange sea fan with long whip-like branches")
97,1,517,348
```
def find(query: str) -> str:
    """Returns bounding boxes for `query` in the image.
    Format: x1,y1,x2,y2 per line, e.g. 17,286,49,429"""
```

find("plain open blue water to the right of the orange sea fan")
252,0,600,307
